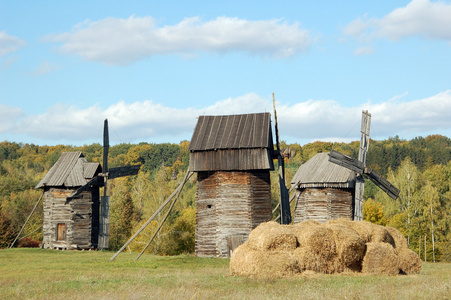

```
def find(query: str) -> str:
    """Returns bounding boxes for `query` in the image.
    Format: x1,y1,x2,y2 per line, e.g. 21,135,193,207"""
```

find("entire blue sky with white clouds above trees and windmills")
0,0,451,145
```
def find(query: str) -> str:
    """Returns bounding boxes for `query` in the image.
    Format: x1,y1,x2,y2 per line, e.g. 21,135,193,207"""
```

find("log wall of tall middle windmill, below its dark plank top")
196,171,272,257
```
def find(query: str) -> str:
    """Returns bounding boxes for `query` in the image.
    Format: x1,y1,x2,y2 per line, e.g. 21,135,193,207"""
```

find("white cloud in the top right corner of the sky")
344,0,451,41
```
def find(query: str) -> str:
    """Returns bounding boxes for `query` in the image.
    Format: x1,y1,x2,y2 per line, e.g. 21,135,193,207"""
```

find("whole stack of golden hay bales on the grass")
230,219,421,277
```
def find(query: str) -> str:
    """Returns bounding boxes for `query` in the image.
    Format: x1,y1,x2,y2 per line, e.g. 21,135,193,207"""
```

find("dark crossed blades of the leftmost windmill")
71,119,141,249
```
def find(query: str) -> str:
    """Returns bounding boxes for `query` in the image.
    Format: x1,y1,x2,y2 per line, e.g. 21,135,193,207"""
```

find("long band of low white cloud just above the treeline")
8,90,451,144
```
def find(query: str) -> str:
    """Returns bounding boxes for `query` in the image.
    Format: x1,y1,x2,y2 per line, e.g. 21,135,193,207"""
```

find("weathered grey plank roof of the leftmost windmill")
35,151,102,188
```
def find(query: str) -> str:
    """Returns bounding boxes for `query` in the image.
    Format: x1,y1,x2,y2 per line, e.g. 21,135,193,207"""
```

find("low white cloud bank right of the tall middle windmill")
278,90,451,140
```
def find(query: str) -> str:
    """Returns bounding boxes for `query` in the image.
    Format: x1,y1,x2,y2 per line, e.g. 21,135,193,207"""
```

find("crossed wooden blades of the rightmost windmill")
329,111,399,221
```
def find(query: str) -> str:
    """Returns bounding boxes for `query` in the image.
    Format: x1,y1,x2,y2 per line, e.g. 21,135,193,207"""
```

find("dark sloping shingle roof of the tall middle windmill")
188,113,272,151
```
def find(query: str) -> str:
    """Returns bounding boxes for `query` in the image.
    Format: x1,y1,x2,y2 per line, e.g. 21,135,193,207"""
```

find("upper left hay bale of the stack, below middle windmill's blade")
248,222,298,251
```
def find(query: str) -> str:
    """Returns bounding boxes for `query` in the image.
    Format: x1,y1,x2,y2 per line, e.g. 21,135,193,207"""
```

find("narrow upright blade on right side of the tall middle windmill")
272,93,291,224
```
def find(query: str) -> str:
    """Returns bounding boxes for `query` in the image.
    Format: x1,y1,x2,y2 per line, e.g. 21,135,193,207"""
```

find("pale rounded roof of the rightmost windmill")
291,153,355,188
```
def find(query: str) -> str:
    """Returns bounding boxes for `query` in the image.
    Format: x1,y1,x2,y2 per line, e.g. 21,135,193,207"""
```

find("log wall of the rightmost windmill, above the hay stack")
294,188,353,223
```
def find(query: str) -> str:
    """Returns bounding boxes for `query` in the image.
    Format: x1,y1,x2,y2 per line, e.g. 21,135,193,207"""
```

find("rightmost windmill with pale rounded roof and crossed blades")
291,111,399,223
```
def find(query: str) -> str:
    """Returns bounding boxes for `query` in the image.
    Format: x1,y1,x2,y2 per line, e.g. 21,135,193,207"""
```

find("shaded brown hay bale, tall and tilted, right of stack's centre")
325,223,365,271
